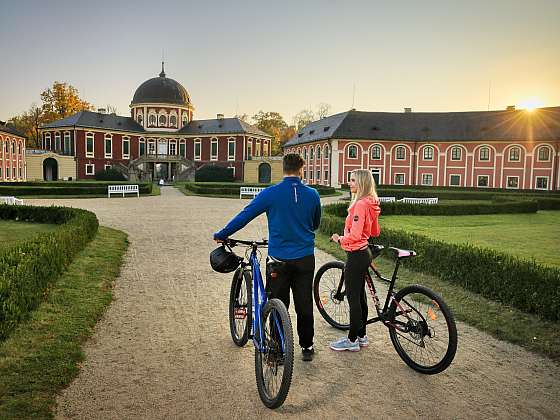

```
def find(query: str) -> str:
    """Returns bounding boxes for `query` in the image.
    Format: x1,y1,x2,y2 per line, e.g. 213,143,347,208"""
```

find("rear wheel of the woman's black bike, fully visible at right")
388,285,457,375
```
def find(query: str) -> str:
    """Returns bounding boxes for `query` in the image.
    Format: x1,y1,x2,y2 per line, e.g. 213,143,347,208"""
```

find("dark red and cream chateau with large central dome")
36,63,271,182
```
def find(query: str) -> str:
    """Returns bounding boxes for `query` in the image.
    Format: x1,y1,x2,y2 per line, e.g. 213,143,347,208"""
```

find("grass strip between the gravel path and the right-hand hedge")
315,233,560,364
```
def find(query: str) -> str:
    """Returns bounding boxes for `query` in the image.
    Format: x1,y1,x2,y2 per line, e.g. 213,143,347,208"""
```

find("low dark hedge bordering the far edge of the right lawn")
324,200,539,217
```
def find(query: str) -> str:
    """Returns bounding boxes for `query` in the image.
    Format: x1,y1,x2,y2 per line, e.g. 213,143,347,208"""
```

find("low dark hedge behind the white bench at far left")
0,182,152,197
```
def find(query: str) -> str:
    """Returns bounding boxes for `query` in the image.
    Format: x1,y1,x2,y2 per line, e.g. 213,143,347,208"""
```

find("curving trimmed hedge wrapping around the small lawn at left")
0,205,99,340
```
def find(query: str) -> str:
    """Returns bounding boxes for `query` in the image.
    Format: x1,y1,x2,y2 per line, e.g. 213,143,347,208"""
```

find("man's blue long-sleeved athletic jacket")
214,176,321,260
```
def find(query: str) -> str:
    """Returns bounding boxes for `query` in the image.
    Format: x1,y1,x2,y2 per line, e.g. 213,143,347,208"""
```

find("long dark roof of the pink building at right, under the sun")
284,107,560,147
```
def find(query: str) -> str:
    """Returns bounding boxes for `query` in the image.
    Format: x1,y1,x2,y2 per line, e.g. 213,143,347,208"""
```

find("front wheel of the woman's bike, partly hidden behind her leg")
313,261,350,330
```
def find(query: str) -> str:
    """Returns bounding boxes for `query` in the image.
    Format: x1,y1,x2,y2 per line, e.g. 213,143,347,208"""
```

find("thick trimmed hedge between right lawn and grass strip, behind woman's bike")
319,212,560,321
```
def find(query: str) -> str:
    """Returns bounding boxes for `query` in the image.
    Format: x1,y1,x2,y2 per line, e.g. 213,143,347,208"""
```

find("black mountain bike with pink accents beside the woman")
313,244,457,374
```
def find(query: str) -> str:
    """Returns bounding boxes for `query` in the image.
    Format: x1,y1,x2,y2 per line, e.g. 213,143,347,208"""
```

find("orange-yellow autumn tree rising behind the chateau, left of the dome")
41,82,93,122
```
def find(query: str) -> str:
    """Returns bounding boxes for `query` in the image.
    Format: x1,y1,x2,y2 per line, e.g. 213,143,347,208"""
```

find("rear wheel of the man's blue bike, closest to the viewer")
255,299,294,408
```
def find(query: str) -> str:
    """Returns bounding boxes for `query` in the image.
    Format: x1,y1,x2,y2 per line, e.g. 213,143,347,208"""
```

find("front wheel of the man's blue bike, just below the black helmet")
229,268,253,347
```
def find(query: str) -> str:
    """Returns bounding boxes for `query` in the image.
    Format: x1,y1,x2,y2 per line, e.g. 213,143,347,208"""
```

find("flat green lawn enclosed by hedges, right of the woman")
380,211,560,267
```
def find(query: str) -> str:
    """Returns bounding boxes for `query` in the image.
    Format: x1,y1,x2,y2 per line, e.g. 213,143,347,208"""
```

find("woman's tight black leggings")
344,248,373,341
